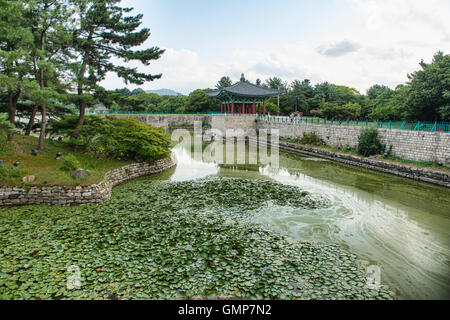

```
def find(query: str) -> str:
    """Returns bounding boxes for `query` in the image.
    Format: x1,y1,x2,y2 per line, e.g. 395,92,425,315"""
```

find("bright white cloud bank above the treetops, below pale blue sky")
100,0,450,93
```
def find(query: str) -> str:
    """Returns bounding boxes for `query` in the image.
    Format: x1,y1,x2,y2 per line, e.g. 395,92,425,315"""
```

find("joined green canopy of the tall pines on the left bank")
0,0,164,148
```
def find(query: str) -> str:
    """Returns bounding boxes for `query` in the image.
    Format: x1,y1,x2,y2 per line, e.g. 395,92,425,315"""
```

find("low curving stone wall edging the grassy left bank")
0,157,176,206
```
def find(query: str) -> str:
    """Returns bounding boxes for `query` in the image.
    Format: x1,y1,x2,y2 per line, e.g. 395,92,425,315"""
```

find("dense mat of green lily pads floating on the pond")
0,178,394,299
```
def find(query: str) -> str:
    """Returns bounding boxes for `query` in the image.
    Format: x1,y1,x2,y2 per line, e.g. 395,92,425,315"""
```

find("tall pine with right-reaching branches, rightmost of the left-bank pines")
70,0,164,137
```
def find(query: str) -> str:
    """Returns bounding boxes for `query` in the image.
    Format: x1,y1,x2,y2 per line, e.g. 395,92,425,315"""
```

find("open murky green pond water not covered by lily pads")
166,143,450,299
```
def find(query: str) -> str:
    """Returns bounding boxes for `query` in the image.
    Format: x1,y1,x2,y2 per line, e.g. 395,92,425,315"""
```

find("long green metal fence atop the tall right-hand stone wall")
258,115,450,133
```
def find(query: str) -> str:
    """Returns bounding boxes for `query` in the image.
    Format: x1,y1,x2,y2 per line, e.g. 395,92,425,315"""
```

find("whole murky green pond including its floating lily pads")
0,144,450,300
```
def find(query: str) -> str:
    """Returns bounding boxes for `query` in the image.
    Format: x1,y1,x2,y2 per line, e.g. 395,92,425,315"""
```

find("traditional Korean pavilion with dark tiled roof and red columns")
206,74,282,115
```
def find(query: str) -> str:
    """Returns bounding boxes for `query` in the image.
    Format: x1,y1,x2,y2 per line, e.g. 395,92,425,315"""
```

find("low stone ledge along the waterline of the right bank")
272,142,450,188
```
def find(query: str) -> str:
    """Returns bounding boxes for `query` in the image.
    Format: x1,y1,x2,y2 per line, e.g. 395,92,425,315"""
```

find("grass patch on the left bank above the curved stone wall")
0,135,130,186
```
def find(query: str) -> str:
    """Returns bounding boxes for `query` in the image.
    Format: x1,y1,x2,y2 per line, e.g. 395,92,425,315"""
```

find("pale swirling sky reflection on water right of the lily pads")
256,168,450,299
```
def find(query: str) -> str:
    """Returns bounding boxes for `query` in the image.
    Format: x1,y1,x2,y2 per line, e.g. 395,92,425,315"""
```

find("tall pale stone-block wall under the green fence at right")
257,121,450,165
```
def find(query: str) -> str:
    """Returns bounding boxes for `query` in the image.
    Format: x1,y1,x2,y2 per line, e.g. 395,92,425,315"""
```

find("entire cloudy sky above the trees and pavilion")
103,0,450,94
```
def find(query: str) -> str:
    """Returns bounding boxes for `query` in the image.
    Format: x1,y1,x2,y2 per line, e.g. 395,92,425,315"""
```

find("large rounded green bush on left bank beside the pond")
50,116,171,162
